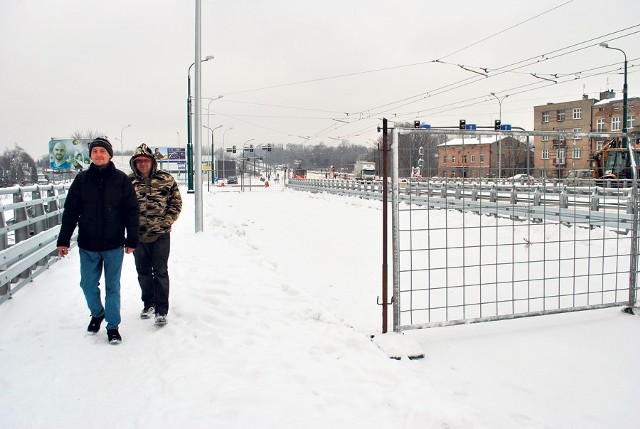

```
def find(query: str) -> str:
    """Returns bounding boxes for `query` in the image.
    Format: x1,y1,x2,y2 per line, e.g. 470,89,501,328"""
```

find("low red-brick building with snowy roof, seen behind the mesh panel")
438,135,533,178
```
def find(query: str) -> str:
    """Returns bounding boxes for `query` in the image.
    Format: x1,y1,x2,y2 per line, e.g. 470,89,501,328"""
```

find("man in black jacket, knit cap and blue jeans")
57,137,139,344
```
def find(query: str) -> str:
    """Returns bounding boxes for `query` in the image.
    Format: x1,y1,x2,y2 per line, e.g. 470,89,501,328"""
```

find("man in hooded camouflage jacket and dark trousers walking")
129,143,182,325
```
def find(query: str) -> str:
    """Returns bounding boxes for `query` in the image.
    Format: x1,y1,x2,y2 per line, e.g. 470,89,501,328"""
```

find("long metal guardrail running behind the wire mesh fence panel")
287,179,633,233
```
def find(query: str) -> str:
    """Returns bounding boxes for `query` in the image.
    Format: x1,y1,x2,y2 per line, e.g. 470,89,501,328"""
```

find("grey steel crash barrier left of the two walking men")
0,184,70,303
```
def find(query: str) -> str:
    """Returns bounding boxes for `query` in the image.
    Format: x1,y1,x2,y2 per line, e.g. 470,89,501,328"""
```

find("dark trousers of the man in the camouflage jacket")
133,234,171,315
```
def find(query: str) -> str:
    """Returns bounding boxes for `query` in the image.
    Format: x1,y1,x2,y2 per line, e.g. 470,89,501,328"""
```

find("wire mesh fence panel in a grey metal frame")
390,124,638,331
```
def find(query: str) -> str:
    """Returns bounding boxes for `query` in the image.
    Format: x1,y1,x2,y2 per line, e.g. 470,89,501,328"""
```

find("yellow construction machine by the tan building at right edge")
592,138,640,188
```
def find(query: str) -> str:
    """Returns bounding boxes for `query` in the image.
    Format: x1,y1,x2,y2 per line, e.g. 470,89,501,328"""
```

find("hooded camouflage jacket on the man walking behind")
129,144,182,243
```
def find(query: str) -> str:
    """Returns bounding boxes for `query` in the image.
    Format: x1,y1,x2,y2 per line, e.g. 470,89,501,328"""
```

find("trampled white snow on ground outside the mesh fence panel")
0,179,640,429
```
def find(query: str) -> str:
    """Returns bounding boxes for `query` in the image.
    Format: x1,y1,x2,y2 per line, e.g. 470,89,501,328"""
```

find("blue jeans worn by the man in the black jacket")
80,247,124,329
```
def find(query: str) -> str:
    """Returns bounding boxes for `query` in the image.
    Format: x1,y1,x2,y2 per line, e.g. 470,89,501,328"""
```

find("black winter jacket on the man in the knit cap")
57,162,139,252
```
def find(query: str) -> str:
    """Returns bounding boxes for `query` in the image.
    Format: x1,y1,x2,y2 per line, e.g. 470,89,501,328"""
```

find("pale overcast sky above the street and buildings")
0,0,640,157
